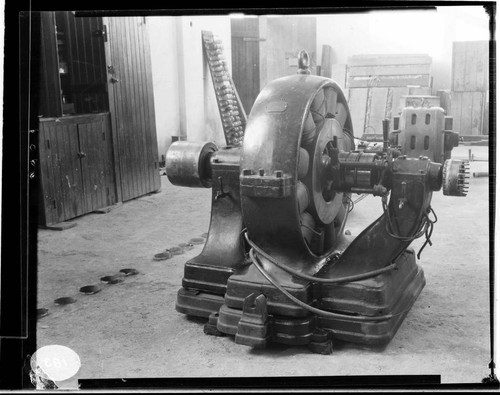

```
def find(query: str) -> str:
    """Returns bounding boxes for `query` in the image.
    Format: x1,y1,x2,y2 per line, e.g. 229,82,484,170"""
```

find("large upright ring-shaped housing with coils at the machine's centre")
241,75,354,262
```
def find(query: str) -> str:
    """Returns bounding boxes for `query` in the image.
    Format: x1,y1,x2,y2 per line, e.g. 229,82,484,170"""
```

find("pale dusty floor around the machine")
37,146,490,383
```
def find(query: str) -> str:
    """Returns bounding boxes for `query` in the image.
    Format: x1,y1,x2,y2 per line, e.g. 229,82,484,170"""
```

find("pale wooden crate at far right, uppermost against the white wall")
451,41,489,92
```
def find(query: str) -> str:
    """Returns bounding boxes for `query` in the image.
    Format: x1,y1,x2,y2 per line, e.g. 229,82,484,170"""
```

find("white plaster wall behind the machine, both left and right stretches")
148,6,489,158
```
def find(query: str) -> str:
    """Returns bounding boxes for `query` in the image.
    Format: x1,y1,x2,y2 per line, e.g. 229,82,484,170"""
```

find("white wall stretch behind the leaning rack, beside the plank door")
148,16,231,158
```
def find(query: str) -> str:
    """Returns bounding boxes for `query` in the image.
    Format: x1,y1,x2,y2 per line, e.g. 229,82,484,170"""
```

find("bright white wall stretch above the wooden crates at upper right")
317,6,489,92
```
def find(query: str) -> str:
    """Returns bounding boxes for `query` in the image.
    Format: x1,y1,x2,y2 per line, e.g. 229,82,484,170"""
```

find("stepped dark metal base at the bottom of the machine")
176,249,425,353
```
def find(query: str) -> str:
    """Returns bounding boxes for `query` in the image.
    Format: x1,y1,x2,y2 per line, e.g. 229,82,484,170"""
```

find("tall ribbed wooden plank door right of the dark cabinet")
104,17,160,201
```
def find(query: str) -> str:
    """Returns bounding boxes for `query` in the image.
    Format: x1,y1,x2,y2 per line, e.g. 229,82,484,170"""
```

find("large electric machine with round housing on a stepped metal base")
166,54,468,354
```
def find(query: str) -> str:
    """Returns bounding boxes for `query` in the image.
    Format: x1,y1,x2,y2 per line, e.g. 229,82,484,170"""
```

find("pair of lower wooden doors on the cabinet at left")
38,113,117,225
